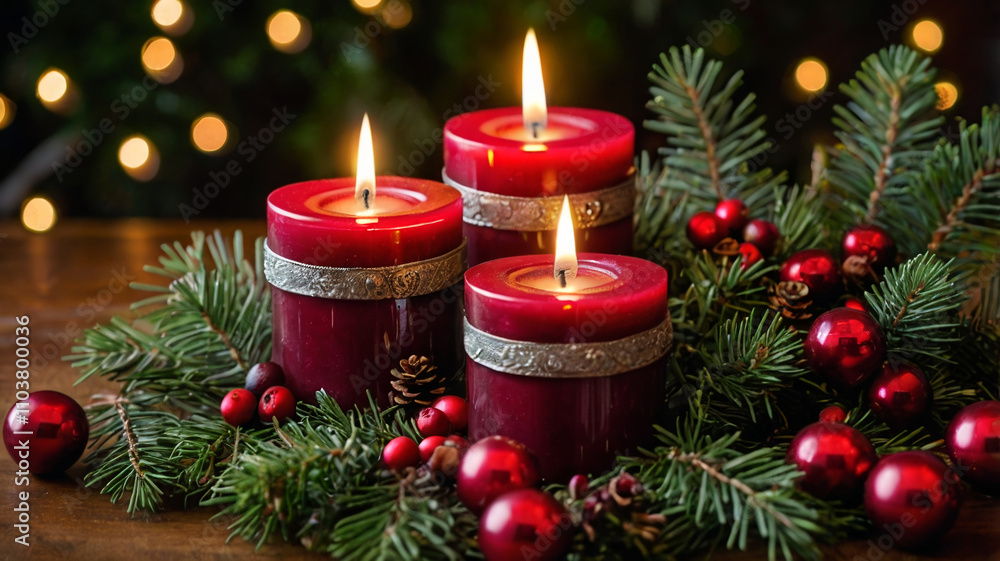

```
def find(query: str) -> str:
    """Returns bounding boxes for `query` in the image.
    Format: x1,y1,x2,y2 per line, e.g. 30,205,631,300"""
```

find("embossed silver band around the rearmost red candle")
441,170,636,232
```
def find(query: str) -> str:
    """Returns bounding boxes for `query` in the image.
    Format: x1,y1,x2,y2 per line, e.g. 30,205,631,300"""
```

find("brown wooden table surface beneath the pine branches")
0,220,1000,561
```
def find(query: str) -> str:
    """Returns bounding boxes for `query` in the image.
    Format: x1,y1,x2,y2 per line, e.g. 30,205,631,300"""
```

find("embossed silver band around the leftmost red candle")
264,240,466,300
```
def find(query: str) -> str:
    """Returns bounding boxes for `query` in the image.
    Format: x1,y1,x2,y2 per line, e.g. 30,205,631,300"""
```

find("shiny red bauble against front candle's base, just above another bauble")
456,436,541,514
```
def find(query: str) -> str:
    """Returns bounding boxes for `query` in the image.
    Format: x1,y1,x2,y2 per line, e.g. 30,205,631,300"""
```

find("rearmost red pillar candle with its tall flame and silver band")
443,29,635,265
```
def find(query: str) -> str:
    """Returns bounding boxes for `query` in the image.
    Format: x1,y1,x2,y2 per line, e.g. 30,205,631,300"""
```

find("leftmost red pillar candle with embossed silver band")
265,118,465,407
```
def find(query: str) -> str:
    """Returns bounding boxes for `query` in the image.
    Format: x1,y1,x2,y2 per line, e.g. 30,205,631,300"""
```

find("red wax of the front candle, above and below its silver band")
465,254,667,482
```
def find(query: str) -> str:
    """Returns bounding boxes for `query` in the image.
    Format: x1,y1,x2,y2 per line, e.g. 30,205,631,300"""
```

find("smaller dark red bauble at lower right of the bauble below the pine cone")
868,362,933,429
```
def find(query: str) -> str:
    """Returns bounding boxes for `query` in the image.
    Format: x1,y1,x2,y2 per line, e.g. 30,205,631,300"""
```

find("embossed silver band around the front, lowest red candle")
465,316,674,378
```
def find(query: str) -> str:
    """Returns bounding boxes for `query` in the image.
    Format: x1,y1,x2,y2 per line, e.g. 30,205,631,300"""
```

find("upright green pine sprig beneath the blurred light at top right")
827,45,942,226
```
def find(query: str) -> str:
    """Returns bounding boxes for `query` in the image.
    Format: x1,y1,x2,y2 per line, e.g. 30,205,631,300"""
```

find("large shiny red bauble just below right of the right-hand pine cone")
803,308,885,388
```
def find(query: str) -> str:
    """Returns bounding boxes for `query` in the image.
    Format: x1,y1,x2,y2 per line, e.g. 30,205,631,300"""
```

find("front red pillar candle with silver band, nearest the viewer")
465,199,671,482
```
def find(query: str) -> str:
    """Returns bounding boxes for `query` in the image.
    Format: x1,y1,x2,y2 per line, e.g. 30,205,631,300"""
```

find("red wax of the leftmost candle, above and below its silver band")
267,176,462,407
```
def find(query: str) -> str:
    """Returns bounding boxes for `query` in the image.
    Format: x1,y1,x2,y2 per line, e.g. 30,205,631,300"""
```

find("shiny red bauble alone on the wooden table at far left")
3,390,90,475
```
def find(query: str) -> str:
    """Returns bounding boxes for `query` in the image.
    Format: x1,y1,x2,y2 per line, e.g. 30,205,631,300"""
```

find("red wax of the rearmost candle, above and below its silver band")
444,107,635,266
